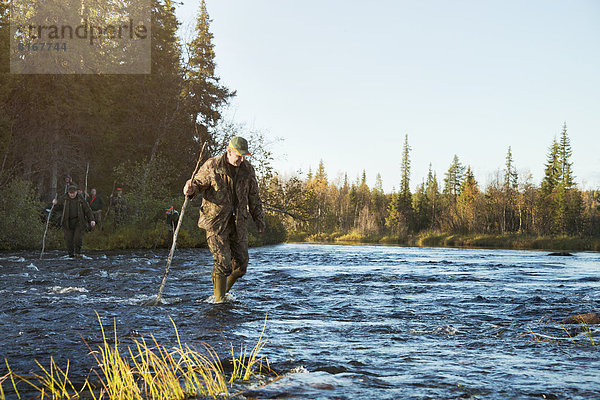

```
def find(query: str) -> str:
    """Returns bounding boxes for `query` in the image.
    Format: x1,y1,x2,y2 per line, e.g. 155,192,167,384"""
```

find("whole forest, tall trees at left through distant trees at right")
0,0,600,247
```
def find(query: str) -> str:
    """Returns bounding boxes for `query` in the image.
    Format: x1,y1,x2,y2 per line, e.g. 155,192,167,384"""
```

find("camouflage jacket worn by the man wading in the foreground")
192,153,265,240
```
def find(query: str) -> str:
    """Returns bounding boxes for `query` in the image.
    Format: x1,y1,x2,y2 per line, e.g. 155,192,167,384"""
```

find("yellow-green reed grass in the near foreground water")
0,313,272,400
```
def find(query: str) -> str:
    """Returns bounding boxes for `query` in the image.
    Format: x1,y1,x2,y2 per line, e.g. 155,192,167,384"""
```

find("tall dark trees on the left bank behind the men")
0,0,272,248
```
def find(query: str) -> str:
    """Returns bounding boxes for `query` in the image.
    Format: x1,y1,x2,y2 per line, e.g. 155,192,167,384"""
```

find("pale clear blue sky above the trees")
178,0,600,191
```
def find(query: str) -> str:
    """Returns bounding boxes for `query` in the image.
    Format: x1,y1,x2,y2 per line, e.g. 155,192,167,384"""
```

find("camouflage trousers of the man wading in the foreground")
206,218,248,278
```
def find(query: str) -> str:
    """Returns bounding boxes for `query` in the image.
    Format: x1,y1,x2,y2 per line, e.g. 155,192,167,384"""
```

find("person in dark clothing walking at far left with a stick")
52,185,96,258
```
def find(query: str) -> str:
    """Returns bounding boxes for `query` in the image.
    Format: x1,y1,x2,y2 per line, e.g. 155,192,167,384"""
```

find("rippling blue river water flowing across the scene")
0,244,600,399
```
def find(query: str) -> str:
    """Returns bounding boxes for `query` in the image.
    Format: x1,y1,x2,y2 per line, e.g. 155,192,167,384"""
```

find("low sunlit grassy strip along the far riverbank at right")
287,232,600,251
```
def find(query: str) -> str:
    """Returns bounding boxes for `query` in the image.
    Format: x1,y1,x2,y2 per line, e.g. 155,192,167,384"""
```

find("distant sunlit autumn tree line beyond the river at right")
263,123,600,239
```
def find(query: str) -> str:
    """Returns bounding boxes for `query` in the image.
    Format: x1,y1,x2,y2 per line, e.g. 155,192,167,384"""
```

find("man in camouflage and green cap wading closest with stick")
183,136,265,303
